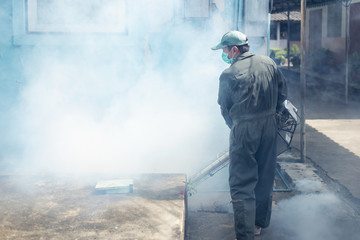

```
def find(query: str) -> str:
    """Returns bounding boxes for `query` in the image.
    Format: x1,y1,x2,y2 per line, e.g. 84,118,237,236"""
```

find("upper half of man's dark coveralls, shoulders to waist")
218,52,286,125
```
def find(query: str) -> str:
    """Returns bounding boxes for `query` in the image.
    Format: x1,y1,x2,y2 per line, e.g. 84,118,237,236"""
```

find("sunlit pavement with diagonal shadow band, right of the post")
306,119,360,199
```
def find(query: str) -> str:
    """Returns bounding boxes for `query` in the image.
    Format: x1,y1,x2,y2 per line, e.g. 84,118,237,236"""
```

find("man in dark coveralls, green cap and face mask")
212,31,287,240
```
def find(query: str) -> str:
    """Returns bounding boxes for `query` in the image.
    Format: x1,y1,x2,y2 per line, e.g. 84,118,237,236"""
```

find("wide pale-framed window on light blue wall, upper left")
27,0,127,33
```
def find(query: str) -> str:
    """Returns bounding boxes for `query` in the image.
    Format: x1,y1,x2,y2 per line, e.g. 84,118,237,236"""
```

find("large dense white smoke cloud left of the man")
2,0,228,176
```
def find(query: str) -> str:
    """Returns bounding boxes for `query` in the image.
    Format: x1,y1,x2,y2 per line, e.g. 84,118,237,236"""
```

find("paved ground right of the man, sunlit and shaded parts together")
261,69,360,240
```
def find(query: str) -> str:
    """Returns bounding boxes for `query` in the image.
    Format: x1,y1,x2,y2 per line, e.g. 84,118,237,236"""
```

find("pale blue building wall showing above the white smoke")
0,0,268,113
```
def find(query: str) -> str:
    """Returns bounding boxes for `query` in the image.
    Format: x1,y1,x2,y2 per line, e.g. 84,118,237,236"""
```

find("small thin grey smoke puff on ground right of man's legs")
271,179,358,240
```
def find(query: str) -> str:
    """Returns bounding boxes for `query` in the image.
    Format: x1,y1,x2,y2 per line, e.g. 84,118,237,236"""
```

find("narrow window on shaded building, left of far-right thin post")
327,3,342,37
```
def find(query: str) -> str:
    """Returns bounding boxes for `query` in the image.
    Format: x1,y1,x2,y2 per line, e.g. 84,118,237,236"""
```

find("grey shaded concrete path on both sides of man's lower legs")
186,149,360,240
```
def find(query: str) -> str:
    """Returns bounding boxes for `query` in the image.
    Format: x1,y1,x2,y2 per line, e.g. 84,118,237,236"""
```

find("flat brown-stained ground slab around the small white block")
0,174,186,239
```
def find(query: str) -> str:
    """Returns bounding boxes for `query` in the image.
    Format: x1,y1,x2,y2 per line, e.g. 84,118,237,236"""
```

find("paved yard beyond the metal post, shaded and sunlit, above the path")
288,68,360,203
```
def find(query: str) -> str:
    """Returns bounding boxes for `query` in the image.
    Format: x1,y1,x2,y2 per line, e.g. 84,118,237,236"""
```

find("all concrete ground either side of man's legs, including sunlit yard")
187,68,360,240
